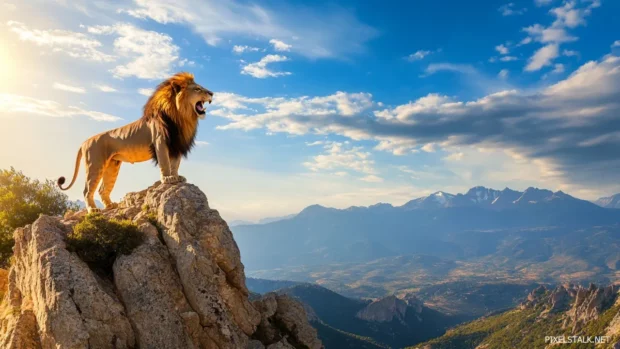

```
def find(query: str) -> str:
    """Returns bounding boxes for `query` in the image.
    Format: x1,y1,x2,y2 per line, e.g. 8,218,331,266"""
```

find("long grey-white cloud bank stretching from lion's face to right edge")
214,55,620,190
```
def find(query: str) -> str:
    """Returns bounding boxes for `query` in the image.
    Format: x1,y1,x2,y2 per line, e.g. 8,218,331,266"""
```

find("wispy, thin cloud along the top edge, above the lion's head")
122,0,378,58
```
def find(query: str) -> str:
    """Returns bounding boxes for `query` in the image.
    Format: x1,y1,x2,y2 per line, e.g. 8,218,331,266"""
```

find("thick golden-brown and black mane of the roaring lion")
142,72,198,162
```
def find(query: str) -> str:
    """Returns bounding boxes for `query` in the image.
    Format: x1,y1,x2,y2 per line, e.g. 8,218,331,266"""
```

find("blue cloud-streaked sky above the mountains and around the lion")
0,0,620,220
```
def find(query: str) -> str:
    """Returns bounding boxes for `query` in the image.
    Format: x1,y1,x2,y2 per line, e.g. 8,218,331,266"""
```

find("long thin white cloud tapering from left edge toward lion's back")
0,93,122,122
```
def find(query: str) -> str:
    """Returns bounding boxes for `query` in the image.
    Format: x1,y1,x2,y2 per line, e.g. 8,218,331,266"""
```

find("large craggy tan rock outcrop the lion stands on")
0,183,322,349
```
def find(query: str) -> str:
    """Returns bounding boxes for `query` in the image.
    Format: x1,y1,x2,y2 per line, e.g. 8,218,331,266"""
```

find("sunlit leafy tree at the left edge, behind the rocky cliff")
0,167,77,267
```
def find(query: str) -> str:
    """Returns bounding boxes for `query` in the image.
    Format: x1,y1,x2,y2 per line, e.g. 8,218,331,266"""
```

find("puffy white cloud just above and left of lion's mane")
88,24,179,80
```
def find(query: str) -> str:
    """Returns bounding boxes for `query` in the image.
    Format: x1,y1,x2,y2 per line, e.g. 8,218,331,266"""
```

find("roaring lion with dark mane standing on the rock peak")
58,72,213,213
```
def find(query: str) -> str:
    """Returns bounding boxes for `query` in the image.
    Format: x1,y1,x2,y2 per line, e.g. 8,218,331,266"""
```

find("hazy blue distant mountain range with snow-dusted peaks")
233,187,620,271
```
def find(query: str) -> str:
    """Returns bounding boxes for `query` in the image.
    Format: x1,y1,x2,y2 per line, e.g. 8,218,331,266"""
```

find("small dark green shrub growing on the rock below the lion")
67,214,144,274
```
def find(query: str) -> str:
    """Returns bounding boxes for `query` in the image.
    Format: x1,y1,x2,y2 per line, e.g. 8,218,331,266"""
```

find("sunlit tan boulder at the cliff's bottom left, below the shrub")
0,216,135,348
